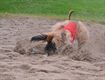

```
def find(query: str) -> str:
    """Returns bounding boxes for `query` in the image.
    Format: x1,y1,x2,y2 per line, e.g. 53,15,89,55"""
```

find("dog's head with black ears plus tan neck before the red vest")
31,31,65,54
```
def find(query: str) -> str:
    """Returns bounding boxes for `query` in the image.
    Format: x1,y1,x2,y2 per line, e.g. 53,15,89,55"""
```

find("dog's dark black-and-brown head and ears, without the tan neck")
31,33,56,53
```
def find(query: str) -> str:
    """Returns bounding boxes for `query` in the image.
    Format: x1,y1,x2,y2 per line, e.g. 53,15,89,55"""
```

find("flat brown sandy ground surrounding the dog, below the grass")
0,16,105,80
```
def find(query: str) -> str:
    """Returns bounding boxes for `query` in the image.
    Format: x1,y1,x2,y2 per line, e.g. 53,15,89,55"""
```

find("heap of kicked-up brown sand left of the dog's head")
14,39,45,55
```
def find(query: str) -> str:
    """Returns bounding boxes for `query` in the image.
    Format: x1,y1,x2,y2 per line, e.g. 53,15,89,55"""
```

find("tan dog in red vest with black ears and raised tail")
31,11,89,56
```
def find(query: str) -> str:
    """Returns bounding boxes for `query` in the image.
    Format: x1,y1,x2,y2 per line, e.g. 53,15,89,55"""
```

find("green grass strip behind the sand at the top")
0,0,105,22
